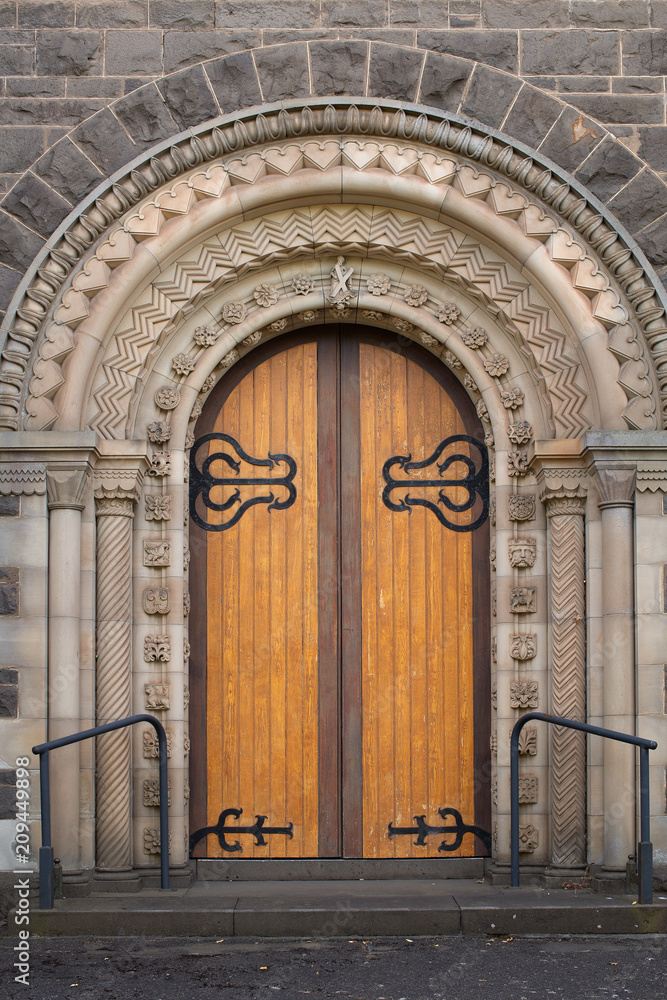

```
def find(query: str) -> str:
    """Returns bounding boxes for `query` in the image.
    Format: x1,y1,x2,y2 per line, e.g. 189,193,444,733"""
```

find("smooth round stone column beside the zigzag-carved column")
595,463,636,868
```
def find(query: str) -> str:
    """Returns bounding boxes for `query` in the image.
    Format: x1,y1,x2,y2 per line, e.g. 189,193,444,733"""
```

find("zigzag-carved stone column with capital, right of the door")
542,490,586,867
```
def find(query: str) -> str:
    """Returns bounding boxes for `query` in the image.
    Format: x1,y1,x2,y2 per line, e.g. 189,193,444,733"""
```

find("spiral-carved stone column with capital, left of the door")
96,491,136,871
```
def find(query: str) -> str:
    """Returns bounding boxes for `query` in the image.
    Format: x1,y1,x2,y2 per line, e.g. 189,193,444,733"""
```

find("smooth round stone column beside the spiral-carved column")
46,464,89,871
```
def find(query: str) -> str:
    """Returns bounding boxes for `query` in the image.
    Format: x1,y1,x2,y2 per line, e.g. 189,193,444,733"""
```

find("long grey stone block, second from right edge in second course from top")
521,29,621,75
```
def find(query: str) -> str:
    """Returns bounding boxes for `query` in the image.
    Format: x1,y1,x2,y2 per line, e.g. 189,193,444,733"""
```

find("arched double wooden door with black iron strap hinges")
190,327,490,858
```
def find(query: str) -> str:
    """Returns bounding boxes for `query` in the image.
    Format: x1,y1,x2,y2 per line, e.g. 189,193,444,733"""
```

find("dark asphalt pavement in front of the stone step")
0,934,667,1000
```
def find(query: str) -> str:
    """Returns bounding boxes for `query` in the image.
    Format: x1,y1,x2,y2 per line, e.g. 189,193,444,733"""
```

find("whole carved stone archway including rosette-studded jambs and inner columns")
0,101,666,880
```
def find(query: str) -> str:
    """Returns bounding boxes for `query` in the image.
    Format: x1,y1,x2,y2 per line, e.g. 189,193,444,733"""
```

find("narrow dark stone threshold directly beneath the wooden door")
196,857,486,882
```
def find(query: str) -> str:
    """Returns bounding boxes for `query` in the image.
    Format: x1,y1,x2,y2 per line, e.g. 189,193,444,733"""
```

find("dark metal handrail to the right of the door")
510,712,658,903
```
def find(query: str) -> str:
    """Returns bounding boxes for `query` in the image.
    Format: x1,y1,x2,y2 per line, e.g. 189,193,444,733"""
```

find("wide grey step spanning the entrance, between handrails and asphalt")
7,879,667,938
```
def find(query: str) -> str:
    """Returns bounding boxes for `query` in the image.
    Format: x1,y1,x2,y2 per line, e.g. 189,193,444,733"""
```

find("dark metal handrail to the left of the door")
32,715,169,910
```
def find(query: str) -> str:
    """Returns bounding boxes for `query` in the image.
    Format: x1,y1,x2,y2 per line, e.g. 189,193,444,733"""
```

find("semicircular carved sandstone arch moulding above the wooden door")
0,99,667,447
